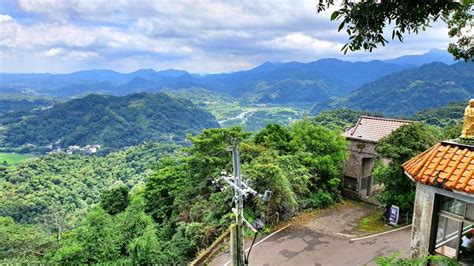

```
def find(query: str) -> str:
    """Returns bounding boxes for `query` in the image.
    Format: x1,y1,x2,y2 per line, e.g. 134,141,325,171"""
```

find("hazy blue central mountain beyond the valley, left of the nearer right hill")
205,59,408,104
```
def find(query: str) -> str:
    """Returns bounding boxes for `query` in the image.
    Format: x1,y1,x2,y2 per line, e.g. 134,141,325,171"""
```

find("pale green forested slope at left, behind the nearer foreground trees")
0,143,179,224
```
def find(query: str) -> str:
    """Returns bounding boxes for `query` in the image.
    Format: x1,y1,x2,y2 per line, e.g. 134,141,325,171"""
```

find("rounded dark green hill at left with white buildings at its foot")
0,93,218,152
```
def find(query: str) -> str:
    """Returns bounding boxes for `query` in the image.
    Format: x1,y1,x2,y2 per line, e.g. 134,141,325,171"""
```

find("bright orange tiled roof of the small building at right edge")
403,142,474,194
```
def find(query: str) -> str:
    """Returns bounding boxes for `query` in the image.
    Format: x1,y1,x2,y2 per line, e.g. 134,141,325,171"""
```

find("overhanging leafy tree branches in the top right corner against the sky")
317,0,474,61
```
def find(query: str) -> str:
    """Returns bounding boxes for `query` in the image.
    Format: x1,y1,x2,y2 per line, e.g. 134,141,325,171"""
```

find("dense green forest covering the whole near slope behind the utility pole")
0,120,346,264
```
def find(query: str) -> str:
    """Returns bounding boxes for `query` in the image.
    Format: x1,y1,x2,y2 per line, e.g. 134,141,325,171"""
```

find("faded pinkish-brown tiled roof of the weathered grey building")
343,116,412,143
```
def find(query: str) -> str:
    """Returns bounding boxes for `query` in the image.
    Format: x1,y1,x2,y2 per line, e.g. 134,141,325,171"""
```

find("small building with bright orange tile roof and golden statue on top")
403,100,474,265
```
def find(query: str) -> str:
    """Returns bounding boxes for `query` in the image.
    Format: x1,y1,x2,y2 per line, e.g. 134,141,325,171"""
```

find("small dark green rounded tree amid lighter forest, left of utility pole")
100,185,129,215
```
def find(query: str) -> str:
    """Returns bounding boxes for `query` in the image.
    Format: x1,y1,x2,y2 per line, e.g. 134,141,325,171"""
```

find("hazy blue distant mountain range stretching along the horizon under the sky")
0,50,452,105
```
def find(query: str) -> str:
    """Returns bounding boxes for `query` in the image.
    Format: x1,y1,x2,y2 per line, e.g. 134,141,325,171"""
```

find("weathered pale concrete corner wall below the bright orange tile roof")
410,183,436,257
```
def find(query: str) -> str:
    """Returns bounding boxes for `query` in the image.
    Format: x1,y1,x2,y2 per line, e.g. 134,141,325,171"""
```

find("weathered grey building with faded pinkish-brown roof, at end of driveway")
341,116,411,202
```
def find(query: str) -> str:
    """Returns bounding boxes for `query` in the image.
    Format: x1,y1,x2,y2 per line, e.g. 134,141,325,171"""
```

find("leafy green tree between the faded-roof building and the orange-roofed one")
374,122,436,218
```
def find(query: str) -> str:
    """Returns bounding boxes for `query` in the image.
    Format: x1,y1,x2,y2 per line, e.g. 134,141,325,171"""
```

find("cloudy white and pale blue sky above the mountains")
0,0,449,73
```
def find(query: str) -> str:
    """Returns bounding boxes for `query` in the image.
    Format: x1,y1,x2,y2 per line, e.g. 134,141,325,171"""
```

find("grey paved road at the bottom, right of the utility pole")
211,204,411,266
